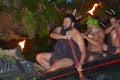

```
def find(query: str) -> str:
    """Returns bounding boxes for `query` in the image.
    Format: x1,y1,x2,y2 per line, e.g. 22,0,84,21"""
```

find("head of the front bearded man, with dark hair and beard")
63,14,75,28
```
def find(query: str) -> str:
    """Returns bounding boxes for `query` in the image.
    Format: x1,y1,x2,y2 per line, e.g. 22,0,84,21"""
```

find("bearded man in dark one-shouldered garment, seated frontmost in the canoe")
36,15,86,72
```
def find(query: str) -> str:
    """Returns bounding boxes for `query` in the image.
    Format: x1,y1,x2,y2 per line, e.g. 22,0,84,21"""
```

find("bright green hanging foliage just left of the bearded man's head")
21,0,61,38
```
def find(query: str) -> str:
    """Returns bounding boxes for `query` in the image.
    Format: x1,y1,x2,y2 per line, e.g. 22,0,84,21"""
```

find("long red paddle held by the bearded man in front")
68,39,87,80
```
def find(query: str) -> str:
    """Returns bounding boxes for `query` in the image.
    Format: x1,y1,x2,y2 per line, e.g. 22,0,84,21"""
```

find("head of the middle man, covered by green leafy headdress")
87,16,100,28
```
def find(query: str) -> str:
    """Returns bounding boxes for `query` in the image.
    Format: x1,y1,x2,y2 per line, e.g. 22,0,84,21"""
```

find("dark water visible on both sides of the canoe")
0,39,120,80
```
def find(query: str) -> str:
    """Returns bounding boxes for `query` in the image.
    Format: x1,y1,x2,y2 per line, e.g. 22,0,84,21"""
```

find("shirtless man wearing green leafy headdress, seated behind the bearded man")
82,16,105,61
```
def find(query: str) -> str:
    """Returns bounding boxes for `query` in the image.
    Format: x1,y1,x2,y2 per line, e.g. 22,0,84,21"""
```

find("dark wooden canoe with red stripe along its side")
38,54,120,80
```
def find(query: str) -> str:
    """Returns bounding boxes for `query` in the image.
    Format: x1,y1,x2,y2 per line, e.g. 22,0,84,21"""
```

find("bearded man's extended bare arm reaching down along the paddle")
74,32,86,65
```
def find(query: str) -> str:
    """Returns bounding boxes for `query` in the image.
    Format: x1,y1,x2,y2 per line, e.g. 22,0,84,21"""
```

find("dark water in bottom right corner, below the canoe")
85,62,120,80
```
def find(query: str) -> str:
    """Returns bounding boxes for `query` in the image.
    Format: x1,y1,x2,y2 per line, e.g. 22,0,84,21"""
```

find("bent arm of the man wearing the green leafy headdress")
83,31,105,47
